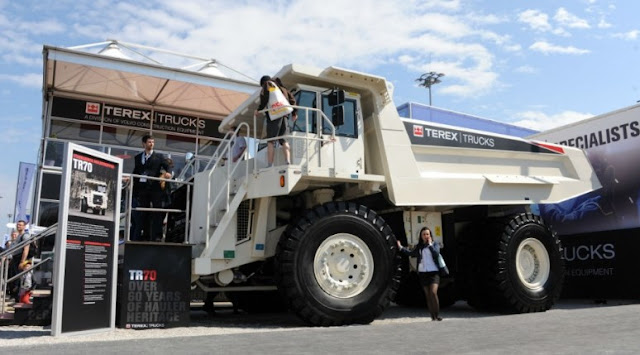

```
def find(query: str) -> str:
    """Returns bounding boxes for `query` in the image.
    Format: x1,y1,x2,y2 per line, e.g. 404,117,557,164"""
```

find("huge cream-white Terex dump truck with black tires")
189,65,599,325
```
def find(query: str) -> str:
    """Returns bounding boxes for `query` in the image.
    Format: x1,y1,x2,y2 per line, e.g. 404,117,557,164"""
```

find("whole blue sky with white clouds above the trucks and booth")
0,0,640,225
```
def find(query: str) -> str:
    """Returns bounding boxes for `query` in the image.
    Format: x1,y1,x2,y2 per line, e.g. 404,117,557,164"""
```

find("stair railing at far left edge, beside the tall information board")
0,223,58,313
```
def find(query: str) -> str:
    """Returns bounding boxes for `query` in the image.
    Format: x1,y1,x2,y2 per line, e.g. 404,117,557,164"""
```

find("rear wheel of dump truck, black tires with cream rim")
463,213,564,313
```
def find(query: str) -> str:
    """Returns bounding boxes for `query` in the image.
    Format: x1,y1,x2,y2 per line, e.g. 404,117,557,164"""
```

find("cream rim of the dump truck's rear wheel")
516,238,551,290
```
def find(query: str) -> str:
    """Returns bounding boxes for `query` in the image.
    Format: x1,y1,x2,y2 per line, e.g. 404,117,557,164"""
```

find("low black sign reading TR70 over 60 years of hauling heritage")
118,242,191,329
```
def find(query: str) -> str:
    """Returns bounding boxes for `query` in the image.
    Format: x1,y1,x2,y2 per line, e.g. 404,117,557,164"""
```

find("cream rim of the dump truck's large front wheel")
313,233,374,298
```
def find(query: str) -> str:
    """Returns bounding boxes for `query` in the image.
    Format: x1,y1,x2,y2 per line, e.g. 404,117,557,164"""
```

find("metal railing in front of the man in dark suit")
122,174,193,244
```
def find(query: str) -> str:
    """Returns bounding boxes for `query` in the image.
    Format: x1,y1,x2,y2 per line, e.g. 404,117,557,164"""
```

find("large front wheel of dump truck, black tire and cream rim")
276,203,400,326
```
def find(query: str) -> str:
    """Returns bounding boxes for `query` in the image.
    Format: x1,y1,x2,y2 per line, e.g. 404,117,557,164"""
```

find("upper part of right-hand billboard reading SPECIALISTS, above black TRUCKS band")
530,105,640,235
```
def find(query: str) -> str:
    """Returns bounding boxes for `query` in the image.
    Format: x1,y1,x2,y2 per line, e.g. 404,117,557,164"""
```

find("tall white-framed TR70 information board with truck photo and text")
51,143,122,335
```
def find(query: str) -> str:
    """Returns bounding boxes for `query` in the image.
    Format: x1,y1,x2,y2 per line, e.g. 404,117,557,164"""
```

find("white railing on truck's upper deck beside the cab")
253,105,336,175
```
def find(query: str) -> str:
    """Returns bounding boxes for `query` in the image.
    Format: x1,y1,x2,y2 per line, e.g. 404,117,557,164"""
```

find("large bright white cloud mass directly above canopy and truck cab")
43,0,504,95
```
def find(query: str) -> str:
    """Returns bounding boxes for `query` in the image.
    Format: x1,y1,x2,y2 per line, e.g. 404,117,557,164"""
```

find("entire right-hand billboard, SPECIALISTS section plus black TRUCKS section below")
530,105,640,298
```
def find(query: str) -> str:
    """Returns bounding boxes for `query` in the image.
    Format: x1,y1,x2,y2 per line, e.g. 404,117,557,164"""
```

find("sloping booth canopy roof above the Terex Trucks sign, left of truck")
43,46,258,119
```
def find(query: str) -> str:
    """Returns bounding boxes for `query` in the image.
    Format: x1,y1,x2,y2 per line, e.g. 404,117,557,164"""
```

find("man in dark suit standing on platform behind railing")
131,135,171,241
